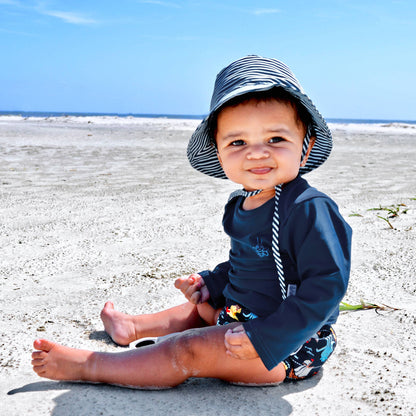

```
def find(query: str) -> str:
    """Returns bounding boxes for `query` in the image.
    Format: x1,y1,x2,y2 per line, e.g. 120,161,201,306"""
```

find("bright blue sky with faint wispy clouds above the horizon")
0,0,416,120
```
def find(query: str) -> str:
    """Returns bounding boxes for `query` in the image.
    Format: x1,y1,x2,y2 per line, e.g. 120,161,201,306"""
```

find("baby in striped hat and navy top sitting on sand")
32,56,351,388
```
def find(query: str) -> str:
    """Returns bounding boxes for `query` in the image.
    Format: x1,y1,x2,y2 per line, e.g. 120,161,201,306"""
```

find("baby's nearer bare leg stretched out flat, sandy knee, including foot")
32,324,285,388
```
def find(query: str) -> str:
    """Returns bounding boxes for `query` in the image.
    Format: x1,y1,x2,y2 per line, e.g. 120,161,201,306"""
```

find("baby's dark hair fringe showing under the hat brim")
207,87,311,147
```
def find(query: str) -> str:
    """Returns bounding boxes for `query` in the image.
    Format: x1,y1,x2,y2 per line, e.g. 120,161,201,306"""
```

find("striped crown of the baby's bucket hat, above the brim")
210,55,303,112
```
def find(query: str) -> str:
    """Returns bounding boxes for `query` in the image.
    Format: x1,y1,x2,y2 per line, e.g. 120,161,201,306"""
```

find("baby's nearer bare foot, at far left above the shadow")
32,339,93,381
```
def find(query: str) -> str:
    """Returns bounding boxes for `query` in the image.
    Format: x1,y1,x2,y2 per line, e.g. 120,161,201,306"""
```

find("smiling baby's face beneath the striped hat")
216,100,305,191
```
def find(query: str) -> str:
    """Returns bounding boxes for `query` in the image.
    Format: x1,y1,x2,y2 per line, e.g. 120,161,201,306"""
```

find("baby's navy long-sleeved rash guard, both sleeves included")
200,177,351,370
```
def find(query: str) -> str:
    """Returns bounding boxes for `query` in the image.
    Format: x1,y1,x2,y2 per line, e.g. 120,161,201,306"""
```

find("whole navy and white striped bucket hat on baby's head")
187,55,332,179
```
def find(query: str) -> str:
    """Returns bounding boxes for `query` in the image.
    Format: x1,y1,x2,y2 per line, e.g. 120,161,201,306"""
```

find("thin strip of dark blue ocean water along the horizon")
0,111,416,124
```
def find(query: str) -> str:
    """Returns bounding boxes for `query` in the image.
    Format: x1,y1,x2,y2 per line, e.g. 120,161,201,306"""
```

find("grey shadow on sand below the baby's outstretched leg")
8,374,322,416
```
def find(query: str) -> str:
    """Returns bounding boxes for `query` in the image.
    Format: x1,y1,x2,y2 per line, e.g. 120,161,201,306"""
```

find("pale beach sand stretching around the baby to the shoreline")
0,116,416,416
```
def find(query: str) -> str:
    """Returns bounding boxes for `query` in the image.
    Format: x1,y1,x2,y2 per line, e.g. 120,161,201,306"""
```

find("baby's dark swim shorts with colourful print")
217,304,337,380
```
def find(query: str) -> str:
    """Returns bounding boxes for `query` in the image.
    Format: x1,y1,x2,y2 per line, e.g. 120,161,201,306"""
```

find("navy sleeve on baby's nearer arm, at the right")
244,198,351,370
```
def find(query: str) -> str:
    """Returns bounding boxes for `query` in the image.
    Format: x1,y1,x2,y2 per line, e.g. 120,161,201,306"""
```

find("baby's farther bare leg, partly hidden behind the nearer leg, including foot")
101,302,210,345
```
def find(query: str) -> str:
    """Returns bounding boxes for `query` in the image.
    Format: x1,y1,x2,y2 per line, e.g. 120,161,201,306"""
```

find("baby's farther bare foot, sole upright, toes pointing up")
101,302,138,345
